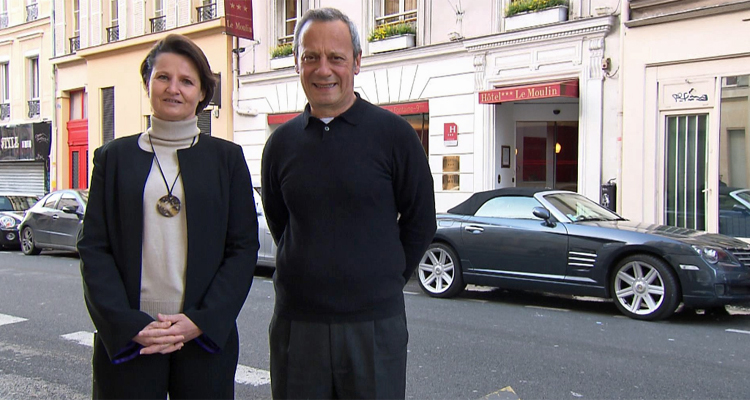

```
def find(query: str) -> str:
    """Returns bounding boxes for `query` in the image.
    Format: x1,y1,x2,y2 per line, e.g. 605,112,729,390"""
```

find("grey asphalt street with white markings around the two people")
0,251,750,400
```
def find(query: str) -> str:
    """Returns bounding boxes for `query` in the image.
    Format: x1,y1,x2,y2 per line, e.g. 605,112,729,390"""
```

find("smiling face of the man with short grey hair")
294,21,362,118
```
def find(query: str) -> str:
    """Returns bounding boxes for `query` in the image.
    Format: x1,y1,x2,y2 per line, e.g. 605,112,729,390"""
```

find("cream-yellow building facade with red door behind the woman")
51,0,236,192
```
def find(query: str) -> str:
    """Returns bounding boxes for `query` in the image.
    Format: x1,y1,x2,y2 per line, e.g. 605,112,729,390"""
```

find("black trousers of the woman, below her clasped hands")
92,329,239,400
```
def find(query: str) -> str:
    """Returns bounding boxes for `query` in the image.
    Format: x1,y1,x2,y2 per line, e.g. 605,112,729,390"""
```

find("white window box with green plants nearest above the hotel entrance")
505,0,568,31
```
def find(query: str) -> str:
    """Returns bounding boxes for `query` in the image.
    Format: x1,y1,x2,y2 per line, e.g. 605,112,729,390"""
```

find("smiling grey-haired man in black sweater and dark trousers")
262,8,436,399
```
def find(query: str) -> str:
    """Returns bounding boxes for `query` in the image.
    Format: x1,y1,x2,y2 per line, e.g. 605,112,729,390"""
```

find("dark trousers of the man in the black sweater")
269,313,409,399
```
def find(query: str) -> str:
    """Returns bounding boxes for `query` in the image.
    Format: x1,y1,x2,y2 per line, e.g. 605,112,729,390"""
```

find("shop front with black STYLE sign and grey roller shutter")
0,122,52,195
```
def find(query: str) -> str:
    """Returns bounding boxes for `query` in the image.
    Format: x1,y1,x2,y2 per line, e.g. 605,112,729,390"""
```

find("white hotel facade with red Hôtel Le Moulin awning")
234,0,620,211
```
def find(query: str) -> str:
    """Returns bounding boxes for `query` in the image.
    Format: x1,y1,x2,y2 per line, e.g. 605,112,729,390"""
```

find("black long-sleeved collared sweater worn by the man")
261,96,436,321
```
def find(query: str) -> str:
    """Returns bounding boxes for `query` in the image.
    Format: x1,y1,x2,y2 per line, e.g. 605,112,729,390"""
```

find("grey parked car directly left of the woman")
19,189,89,255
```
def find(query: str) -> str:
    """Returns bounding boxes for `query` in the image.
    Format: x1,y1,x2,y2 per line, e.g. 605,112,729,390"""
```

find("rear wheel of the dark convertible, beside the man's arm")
417,243,466,297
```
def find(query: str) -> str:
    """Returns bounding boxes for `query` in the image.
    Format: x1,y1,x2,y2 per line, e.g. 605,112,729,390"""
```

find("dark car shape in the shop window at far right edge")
719,186,750,237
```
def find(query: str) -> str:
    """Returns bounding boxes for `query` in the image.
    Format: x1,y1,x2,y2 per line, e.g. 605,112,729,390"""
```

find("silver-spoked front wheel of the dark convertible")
612,255,680,321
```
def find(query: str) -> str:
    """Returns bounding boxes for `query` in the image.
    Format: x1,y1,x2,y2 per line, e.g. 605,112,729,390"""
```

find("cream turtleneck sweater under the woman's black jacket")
138,116,200,319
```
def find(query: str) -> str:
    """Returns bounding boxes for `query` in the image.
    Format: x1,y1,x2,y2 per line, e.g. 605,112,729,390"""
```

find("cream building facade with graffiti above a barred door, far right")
618,0,750,239
